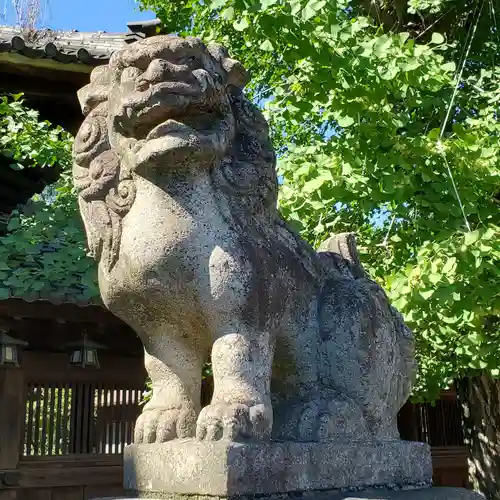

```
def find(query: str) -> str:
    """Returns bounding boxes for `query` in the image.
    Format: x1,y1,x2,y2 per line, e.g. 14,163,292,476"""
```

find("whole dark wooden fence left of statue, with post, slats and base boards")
0,353,145,500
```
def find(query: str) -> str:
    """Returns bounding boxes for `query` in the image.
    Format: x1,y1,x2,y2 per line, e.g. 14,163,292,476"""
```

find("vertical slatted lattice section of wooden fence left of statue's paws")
23,381,143,457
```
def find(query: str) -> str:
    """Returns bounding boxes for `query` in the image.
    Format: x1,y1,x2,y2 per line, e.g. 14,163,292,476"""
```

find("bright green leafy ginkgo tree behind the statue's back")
138,0,500,492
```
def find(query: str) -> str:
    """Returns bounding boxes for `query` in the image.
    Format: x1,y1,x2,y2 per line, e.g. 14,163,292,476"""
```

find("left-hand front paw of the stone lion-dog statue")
134,407,196,444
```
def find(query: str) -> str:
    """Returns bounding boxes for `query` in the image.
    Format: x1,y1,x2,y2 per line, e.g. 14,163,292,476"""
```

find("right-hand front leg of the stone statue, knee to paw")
196,332,273,441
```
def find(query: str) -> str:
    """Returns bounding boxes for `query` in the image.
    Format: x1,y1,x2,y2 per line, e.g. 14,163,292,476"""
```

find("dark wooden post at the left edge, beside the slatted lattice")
0,367,25,471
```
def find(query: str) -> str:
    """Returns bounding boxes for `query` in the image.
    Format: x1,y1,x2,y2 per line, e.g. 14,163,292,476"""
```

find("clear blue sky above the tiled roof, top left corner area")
0,0,155,32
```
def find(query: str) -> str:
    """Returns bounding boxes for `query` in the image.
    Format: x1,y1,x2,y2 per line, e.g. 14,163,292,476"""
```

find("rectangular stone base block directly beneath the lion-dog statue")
124,440,432,498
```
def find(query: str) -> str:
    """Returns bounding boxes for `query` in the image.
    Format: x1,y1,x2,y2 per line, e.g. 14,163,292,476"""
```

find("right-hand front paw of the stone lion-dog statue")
196,403,273,441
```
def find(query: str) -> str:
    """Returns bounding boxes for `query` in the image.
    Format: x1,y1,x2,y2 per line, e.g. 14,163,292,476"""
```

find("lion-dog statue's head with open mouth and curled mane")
73,36,276,270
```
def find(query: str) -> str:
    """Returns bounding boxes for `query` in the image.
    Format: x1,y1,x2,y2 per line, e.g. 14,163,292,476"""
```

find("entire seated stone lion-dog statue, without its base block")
74,36,415,443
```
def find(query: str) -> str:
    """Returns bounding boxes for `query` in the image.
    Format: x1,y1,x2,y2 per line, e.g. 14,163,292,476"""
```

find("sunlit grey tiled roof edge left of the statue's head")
0,26,128,66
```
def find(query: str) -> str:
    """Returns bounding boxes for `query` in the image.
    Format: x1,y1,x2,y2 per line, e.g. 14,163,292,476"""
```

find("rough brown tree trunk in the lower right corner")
458,374,500,500
